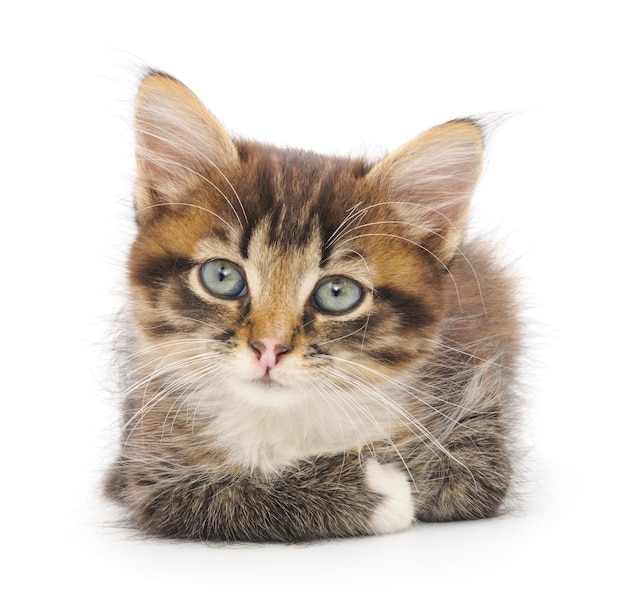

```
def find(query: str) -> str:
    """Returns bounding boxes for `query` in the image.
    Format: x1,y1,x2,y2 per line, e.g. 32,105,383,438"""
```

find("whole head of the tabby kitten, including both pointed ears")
124,73,482,406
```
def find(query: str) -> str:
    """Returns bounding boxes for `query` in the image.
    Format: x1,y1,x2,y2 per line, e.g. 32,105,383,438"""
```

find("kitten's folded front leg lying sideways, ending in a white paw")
122,454,414,542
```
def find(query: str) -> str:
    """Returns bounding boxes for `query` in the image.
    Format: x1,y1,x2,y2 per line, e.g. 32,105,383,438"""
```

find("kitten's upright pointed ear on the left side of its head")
135,72,239,210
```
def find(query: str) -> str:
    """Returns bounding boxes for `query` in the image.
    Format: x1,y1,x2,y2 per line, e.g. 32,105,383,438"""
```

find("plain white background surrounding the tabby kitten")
0,0,626,606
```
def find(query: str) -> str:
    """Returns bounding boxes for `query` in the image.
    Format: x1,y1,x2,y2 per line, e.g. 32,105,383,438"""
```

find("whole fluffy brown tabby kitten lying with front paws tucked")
107,72,519,542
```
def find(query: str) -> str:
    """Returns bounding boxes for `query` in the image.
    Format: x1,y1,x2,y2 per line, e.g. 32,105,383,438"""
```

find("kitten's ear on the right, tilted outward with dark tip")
368,120,483,263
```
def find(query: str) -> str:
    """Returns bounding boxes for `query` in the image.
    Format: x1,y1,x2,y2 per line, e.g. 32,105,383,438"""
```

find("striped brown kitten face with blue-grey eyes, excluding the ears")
130,144,446,407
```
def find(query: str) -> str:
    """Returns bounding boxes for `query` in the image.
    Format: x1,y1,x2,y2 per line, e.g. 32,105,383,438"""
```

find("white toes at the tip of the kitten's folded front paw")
364,458,413,534
